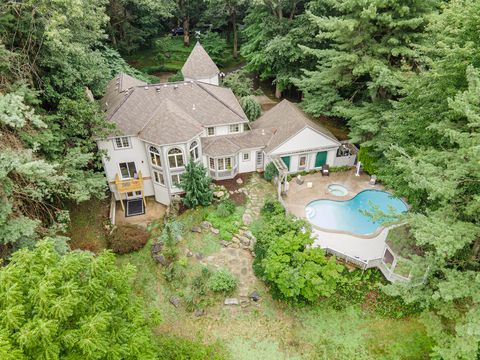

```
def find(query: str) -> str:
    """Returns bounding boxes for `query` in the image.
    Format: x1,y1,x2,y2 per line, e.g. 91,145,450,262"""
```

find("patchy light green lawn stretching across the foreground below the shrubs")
118,207,432,360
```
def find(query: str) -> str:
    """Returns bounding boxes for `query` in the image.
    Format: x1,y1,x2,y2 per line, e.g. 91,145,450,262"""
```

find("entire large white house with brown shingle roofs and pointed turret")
98,44,356,211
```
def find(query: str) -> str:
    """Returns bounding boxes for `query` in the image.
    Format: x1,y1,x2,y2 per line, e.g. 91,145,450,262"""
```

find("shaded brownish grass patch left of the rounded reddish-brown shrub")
67,199,110,253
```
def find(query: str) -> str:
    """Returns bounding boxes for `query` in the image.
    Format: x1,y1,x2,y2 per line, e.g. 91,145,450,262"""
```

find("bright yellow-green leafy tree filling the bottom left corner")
0,240,154,359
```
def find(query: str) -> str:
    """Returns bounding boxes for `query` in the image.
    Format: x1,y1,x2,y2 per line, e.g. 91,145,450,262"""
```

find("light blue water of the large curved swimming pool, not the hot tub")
305,190,408,235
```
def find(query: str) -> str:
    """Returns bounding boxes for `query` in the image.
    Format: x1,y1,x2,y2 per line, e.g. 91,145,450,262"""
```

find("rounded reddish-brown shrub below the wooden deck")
108,225,149,254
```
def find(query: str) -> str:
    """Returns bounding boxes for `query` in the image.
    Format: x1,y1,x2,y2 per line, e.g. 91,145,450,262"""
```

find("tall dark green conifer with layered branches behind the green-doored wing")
294,0,438,145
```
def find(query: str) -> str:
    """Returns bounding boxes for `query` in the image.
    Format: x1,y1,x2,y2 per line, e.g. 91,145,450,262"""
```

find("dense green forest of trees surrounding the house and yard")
0,0,480,359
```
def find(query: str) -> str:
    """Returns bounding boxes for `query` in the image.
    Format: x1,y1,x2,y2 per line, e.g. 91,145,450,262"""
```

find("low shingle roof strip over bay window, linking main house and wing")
202,129,273,157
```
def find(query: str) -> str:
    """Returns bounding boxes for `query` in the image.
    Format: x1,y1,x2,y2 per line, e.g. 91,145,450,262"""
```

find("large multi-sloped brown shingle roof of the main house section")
101,75,248,145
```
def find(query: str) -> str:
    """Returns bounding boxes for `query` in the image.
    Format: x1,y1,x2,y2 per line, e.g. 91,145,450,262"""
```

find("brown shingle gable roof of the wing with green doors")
251,100,340,153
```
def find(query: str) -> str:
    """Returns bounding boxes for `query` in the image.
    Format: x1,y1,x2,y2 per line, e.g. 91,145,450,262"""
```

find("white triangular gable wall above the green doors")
271,128,340,155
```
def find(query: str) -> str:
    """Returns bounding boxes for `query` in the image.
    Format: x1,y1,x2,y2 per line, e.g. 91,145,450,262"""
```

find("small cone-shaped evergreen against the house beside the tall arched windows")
179,159,213,208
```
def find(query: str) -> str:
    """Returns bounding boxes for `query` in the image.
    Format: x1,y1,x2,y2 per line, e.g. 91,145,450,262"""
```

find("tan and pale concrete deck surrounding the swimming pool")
283,169,388,262
